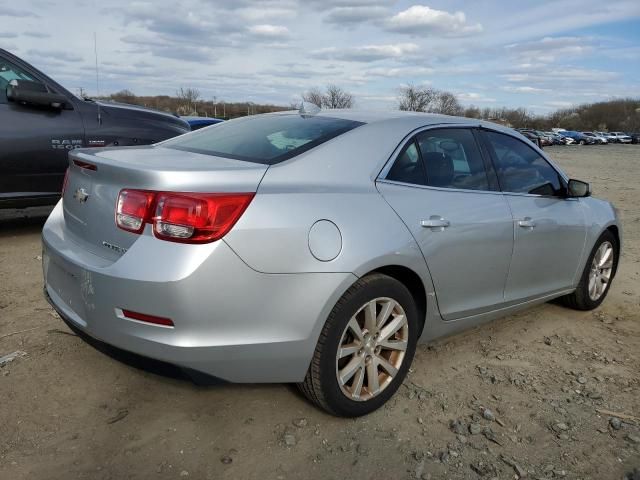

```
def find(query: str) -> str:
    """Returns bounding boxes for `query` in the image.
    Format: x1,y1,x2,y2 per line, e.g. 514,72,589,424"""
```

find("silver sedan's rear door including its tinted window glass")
377,128,513,320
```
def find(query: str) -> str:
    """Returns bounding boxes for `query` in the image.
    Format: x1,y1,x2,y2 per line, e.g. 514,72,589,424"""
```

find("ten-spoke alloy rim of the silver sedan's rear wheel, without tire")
336,297,409,401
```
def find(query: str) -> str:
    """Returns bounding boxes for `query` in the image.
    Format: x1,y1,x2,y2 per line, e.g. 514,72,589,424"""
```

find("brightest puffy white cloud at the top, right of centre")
386,5,482,37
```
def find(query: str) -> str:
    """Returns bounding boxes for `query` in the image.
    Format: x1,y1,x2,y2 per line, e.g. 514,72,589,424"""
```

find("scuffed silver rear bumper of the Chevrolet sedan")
43,205,356,382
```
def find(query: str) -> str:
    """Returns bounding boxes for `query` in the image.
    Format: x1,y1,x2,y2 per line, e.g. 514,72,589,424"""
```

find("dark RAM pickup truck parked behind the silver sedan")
0,49,190,208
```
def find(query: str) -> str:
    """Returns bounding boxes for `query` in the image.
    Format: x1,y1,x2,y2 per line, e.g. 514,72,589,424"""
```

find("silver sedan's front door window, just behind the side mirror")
484,132,562,196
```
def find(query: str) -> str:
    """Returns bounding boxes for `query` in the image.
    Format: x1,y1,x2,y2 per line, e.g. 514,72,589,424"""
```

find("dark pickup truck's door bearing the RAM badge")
0,51,84,201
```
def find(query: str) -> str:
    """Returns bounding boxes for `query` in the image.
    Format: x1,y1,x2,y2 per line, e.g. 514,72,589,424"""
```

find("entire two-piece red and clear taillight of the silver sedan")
116,189,254,243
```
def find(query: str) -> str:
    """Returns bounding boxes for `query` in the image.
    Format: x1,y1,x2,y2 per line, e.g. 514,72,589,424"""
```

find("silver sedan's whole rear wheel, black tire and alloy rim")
298,273,418,417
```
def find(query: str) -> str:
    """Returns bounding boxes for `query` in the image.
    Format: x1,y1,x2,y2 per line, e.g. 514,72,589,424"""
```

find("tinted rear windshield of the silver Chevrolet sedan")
162,114,362,165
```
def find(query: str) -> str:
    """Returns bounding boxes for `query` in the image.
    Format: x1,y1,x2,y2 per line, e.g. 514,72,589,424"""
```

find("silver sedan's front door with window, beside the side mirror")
482,130,586,301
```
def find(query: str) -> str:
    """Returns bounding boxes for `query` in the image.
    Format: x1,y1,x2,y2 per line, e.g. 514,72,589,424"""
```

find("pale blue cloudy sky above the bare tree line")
0,0,640,114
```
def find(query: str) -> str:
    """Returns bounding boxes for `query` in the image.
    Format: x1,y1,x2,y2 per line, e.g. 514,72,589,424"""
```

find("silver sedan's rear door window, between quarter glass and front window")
417,128,490,190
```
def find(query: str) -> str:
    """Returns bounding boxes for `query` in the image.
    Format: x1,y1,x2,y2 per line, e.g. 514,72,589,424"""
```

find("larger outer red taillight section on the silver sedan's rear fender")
153,192,253,243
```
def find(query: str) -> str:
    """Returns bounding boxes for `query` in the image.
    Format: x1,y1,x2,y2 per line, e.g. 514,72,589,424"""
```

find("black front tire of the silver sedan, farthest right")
560,230,619,310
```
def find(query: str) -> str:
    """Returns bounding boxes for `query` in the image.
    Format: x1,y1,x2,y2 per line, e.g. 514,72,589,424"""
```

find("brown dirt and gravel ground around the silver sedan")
0,145,640,480
